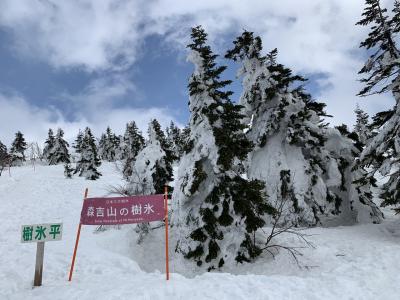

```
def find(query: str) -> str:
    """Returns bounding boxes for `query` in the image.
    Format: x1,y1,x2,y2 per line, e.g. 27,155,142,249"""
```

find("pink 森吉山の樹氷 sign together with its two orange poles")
68,186,169,281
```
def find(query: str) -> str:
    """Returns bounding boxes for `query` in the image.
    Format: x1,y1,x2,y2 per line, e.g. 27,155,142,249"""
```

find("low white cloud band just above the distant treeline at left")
0,94,181,147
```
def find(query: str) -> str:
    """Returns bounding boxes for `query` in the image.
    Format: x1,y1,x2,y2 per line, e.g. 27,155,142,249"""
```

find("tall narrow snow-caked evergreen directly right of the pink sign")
173,27,274,271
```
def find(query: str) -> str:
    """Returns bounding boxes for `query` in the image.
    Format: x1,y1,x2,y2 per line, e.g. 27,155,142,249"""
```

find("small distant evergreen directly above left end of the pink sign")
74,127,101,180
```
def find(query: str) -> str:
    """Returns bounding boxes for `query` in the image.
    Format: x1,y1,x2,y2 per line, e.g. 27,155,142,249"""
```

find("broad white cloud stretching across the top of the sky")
0,0,393,130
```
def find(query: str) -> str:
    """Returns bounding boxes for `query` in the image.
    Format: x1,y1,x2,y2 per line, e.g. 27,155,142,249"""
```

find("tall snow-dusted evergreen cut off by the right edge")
357,0,400,211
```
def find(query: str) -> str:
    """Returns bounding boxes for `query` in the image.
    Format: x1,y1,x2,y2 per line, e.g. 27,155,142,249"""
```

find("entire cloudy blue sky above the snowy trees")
0,0,394,146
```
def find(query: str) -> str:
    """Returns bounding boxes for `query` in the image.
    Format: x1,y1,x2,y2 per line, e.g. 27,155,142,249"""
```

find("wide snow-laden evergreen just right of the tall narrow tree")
226,31,381,225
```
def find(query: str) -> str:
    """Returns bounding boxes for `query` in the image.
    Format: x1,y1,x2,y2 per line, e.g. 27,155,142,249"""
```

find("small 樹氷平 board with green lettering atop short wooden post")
21,223,62,243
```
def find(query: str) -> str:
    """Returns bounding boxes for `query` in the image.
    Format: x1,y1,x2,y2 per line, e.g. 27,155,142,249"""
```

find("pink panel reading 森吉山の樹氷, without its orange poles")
81,195,165,225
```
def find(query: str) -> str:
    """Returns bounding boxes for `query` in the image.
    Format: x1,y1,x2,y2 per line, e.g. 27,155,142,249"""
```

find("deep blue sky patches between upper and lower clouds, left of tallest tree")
0,31,192,121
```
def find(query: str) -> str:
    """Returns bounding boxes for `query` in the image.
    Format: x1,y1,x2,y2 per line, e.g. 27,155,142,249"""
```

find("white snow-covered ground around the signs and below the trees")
0,164,400,300
